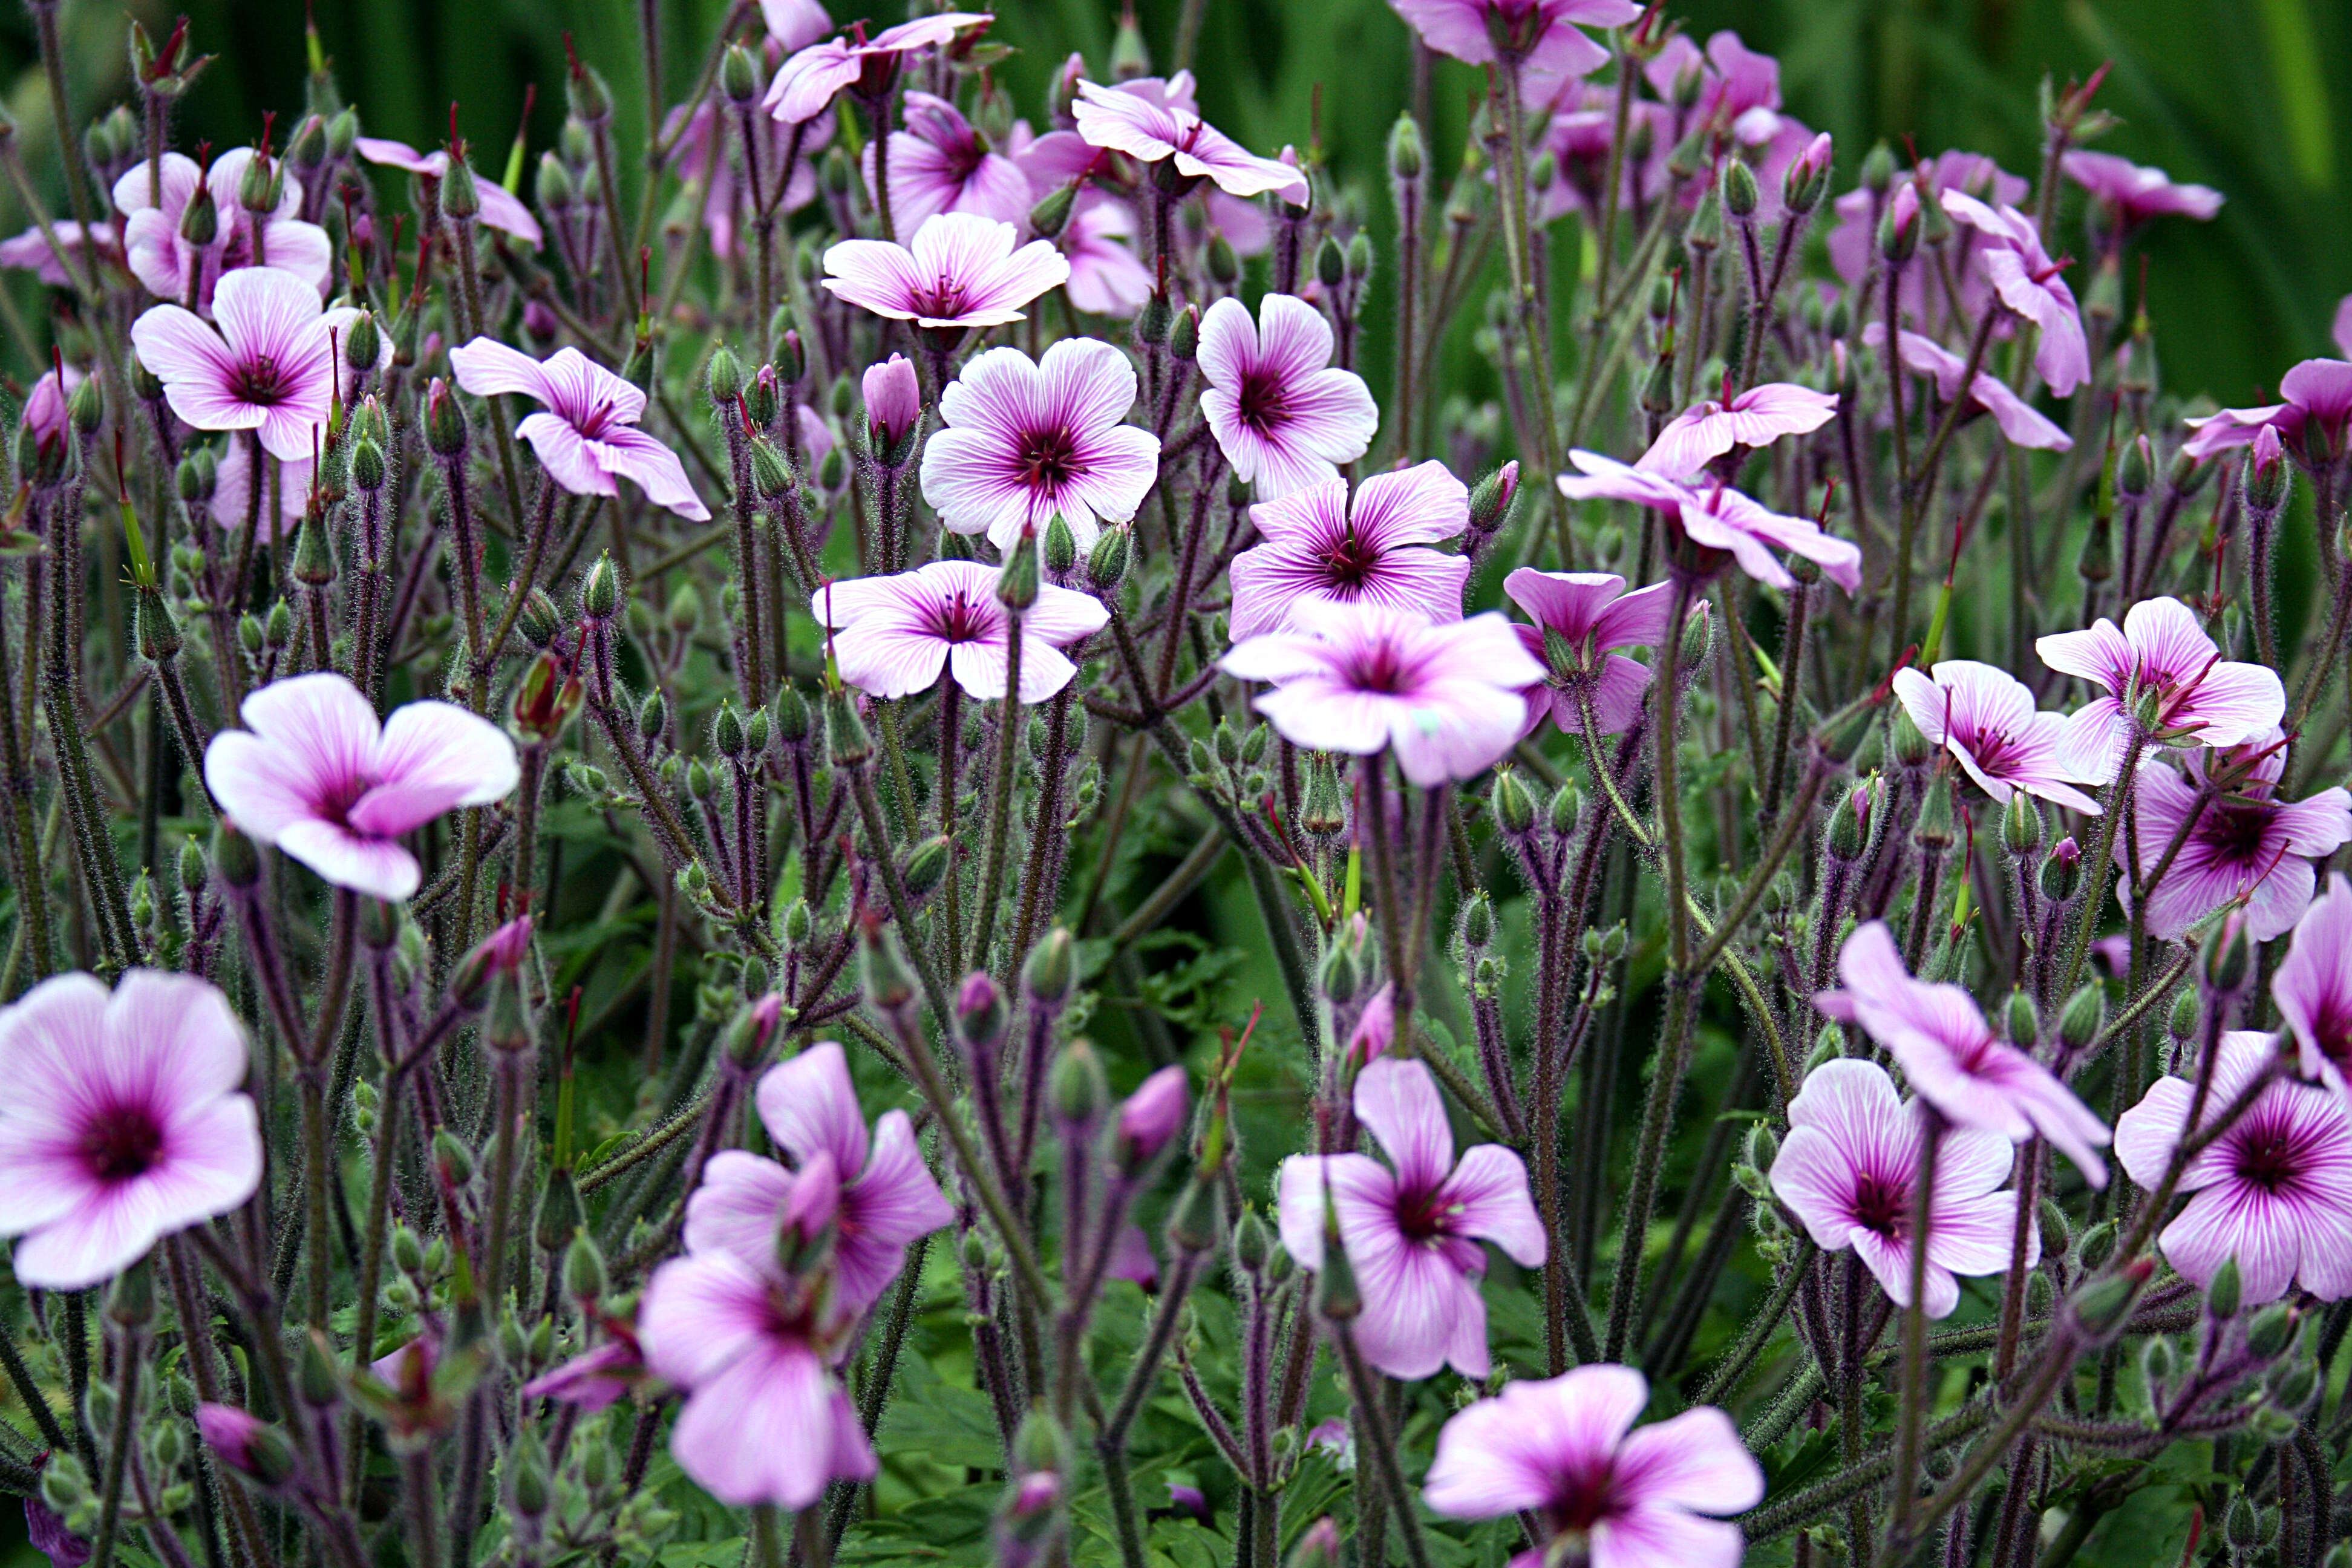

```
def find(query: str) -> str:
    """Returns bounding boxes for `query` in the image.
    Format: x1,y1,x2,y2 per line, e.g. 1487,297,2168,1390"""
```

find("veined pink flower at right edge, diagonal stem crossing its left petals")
2114,1030,2352,1305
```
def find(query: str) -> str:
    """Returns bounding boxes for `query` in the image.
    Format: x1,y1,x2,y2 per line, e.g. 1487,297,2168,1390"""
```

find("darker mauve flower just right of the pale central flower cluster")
1503,567,1674,736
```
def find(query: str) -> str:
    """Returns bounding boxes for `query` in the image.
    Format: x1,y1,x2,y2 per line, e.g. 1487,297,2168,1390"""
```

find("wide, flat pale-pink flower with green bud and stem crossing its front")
809,560,1110,703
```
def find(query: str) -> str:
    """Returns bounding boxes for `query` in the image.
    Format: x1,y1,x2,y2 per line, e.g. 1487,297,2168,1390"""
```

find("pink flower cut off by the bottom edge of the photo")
1420,1364,1764,1568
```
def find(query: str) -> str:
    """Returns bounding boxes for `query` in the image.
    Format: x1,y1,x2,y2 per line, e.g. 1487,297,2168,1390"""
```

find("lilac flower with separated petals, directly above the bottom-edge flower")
1277,1056,1543,1377
